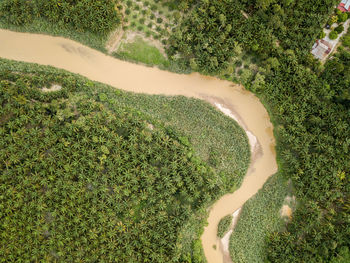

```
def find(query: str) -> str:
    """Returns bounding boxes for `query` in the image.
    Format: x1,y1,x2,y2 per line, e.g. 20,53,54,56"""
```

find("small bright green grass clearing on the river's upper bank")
114,37,169,68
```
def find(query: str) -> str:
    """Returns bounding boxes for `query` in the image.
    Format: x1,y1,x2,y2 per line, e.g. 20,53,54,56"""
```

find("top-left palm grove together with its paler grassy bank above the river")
0,0,120,52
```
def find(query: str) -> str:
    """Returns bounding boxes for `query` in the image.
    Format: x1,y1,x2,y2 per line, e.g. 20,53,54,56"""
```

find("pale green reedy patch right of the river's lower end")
230,174,287,263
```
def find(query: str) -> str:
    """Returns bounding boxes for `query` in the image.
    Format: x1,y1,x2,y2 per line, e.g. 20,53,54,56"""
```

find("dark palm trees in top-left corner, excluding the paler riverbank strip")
0,0,120,35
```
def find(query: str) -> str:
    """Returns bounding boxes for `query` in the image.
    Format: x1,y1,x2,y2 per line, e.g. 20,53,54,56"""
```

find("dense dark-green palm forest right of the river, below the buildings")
168,0,350,262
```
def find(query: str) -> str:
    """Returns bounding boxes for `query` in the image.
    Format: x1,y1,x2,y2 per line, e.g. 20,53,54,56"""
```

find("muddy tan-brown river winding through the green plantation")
0,29,277,263
